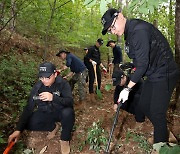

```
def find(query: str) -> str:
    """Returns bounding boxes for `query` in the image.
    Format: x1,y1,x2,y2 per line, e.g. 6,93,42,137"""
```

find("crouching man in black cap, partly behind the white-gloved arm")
112,69,145,122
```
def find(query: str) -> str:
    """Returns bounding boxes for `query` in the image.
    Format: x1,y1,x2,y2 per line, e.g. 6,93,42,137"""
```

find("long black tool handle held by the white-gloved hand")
104,101,122,154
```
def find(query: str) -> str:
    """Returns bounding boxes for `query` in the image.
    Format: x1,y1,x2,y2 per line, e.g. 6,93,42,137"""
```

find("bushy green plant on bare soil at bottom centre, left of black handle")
86,122,107,152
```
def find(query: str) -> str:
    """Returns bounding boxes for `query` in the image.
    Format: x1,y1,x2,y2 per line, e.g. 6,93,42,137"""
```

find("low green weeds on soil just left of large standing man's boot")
126,131,152,152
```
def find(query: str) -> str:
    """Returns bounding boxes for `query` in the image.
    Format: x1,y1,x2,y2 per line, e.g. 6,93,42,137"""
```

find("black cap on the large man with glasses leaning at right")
101,8,120,35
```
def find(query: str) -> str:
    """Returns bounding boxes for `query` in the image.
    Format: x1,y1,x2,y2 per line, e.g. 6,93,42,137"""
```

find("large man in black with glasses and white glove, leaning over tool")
102,8,179,151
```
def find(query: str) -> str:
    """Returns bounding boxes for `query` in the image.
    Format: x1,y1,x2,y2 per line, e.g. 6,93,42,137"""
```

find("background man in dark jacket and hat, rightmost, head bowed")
106,40,122,72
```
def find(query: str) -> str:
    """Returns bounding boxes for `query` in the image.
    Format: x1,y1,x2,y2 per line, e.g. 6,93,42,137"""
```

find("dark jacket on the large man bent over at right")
124,19,177,83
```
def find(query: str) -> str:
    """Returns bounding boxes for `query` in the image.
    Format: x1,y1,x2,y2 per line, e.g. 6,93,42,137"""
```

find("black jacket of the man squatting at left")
16,76,73,131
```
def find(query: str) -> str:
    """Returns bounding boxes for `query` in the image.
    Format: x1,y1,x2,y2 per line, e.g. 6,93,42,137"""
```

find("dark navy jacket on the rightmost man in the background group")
112,45,122,64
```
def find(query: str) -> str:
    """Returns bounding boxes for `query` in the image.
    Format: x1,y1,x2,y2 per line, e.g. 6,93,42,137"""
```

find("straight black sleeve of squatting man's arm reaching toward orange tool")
16,83,41,132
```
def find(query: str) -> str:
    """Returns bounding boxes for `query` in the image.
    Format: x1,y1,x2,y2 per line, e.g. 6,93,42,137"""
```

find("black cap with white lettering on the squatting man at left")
38,62,56,77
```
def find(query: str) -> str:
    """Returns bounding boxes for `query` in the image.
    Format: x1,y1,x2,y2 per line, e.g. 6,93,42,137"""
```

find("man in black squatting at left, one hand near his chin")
8,62,75,154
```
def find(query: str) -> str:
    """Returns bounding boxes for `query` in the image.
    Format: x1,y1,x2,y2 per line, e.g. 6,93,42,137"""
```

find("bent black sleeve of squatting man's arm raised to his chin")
52,81,73,107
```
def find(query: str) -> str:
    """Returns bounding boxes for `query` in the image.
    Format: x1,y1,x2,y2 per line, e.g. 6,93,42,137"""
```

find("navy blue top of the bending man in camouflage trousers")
66,53,86,73
